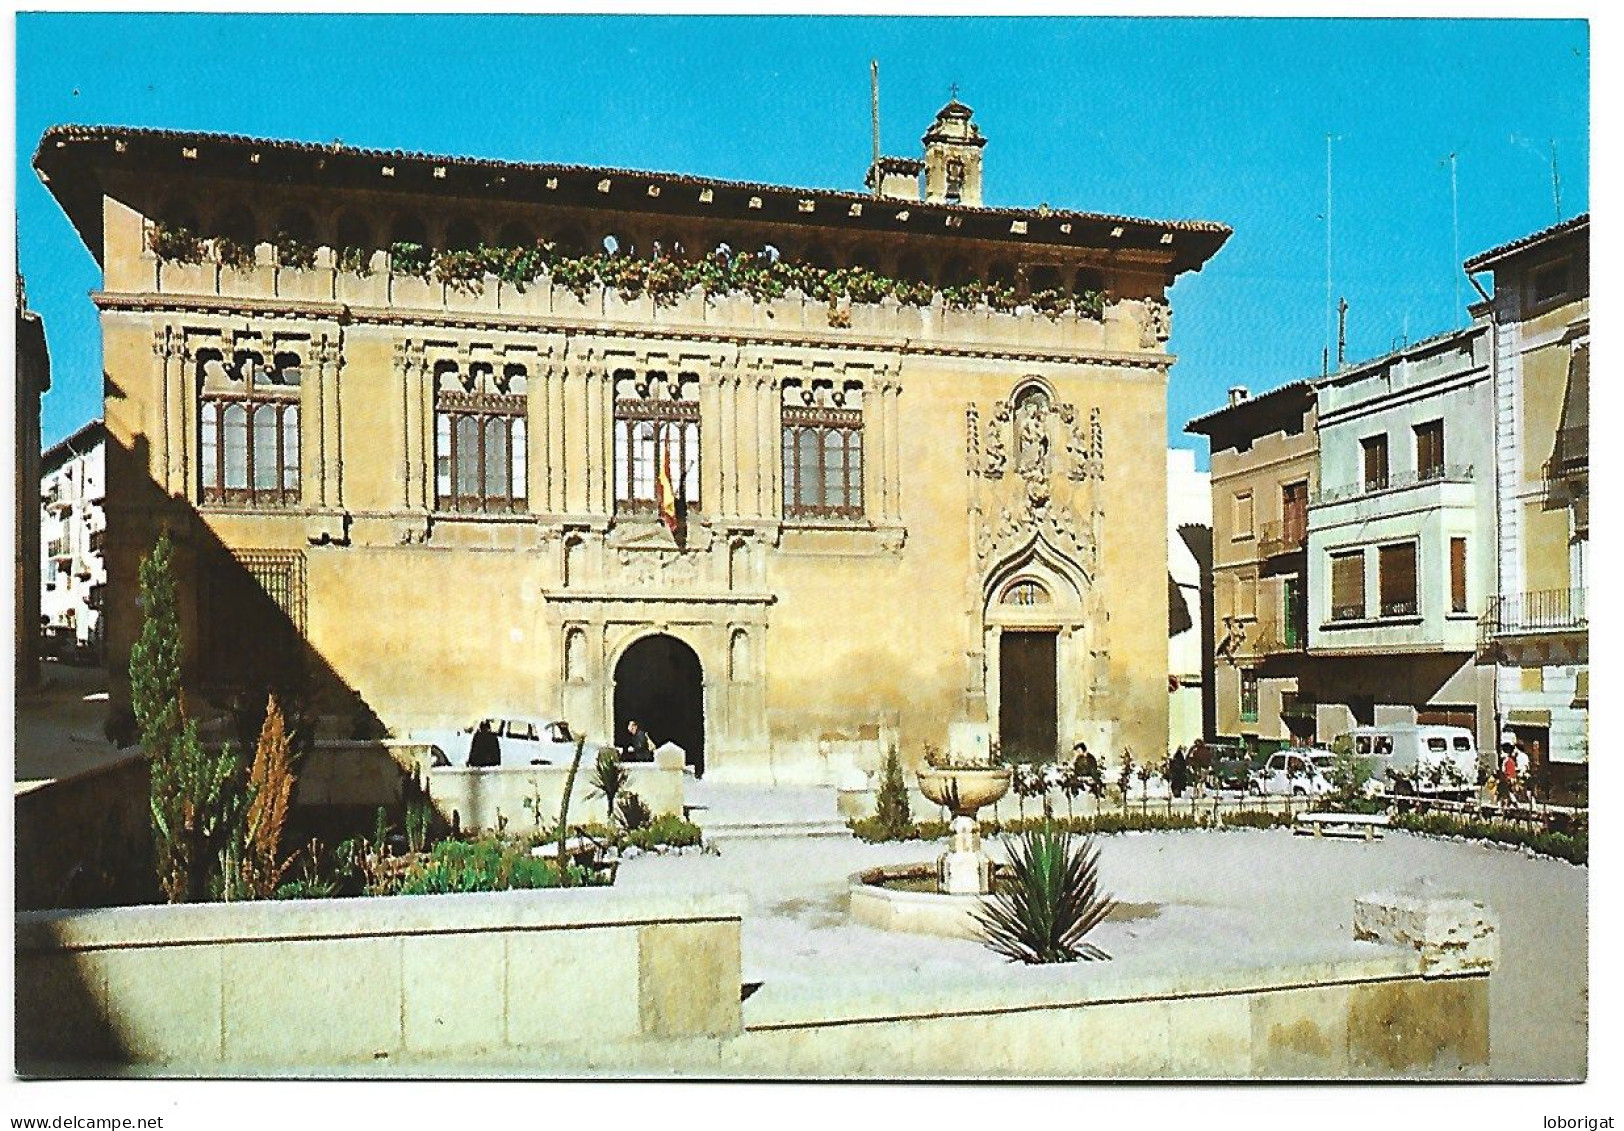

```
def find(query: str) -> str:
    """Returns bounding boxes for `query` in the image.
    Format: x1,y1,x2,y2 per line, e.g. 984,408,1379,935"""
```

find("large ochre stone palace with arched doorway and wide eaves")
34,112,1229,782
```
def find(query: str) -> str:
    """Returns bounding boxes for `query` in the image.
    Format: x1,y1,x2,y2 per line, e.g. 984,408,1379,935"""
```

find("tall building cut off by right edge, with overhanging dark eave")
1465,215,1590,793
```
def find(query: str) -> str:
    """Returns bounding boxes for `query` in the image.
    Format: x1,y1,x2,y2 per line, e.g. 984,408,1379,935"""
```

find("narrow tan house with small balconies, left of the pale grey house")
1186,380,1319,748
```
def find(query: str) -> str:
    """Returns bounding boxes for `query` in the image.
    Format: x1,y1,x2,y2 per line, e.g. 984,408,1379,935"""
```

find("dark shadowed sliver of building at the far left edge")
11,275,50,687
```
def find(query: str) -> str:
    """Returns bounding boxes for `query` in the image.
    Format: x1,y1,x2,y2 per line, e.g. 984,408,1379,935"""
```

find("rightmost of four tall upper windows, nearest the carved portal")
783,380,862,518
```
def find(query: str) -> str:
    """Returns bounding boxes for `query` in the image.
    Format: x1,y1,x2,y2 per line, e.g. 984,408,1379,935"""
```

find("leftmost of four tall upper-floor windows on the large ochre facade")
198,346,300,507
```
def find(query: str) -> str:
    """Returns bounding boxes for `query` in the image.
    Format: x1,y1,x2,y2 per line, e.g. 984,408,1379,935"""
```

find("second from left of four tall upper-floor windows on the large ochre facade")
434,361,528,514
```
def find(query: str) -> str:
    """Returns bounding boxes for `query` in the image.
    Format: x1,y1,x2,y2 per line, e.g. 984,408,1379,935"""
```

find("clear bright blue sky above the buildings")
16,13,1590,465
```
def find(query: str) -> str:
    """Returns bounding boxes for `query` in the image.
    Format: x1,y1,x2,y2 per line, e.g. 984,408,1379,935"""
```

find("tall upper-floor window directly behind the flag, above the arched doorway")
614,369,700,514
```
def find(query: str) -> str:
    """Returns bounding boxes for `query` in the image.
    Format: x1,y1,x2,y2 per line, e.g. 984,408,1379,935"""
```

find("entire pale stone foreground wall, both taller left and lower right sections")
16,889,1494,1079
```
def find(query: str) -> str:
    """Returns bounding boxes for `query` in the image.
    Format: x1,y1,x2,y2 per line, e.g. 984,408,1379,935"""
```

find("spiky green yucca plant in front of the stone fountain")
976,827,1116,964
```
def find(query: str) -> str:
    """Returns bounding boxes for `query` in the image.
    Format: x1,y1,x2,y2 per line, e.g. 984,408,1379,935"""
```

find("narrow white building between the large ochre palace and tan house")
1168,449,1213,751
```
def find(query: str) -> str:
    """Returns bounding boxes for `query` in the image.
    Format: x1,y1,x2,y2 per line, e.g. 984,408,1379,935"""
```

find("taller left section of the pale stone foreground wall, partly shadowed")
16,889,744,1074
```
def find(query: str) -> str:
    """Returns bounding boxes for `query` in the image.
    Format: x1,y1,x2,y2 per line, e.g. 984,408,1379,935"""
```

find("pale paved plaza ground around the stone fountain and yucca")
617,802,1588,1079
